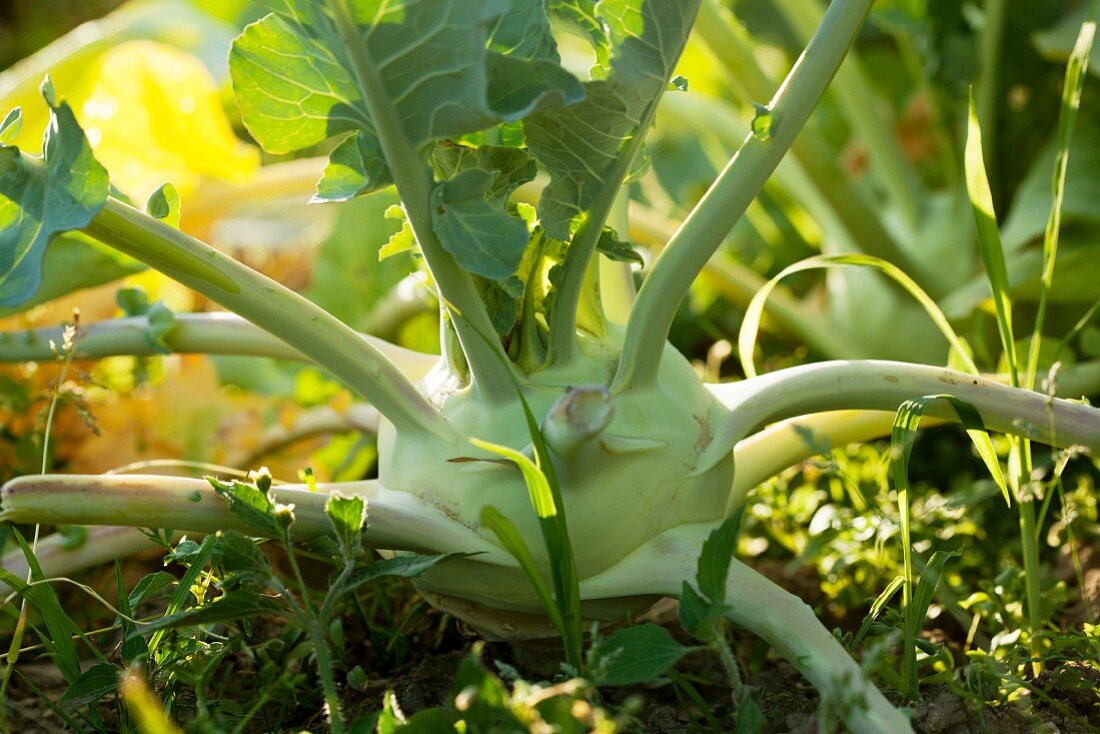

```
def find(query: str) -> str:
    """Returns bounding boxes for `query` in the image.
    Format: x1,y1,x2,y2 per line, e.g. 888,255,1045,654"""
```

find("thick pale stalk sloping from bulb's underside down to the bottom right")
581,525,912,734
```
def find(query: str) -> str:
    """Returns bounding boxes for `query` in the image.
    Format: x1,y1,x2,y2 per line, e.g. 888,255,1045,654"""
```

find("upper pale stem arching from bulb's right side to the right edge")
699,360,1100,467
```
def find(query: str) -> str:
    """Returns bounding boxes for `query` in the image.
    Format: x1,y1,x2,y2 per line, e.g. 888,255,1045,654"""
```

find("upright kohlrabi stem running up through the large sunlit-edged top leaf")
327,0,514,403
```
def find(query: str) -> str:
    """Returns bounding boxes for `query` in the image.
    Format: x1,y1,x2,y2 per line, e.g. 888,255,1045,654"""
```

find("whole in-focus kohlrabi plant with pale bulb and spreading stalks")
0,0,1100,732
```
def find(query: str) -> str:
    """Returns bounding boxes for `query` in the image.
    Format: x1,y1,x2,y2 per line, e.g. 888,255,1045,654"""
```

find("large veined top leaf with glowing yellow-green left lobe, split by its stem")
230,0,583,200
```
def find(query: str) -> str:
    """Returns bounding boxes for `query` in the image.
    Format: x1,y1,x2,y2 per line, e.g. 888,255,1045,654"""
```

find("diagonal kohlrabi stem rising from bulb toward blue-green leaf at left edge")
85,198,451,437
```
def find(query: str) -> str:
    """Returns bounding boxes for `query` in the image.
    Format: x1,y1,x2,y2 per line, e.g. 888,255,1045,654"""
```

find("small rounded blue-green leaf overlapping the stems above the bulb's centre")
431,168,528,281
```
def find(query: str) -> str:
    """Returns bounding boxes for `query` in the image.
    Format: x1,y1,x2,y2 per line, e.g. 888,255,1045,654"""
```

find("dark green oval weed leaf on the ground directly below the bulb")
594,623,691,686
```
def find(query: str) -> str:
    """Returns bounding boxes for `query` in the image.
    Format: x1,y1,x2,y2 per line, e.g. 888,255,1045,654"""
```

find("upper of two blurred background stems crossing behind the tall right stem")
776,0,921,231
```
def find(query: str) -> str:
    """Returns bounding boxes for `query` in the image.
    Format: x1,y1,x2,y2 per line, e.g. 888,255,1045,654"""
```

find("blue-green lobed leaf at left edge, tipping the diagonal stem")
0,80,108,306
